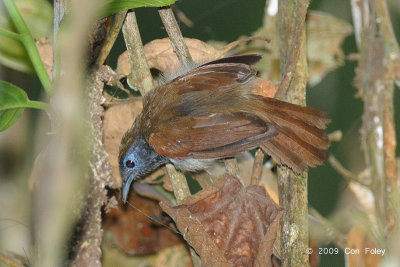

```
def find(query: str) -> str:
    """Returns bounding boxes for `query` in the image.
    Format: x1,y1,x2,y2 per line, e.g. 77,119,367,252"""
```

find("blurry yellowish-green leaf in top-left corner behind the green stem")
0,0,53,73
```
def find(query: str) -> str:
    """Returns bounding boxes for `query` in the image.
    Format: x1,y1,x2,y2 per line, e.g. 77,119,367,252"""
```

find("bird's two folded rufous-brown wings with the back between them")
144,55,277,158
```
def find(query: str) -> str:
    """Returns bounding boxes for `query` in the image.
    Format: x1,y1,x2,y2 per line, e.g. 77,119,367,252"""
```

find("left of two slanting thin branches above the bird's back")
122,11,154,96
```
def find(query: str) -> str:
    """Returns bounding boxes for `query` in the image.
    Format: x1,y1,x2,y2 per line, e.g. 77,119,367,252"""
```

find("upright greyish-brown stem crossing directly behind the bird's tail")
276,0,309,266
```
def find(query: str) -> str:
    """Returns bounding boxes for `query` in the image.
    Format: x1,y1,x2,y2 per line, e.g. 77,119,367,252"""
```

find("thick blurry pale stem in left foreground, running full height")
34,1,101,267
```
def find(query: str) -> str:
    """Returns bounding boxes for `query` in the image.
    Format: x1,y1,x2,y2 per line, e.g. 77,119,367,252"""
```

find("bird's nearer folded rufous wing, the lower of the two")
149,113,277,159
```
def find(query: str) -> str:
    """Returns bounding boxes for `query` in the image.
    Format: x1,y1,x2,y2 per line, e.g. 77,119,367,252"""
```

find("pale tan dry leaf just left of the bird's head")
103,101,142,188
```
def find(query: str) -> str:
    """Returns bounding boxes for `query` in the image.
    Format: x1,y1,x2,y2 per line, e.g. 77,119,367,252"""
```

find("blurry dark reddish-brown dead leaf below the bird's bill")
103,192,183,255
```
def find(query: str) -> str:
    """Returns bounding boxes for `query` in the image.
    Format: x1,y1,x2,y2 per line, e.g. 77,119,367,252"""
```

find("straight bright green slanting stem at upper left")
4,0,51,93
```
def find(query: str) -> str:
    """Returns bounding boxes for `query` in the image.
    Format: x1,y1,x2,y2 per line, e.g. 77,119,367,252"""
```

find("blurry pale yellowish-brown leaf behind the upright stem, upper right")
248,11,352,86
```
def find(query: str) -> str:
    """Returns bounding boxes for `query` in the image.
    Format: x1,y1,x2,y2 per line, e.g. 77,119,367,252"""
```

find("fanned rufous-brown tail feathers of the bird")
257,98,330,173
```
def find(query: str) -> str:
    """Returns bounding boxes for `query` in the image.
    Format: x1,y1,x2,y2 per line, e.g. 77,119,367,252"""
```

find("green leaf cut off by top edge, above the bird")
103,0,176,17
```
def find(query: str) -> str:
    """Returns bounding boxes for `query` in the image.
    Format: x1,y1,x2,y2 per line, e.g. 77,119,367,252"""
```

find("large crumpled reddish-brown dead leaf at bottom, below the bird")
160,174,282,266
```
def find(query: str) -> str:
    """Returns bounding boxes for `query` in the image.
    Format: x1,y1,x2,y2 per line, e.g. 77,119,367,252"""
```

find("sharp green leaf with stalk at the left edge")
0,81,48,132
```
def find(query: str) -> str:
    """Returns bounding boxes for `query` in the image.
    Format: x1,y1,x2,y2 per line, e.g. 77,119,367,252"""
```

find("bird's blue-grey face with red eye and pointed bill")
119,138,169,202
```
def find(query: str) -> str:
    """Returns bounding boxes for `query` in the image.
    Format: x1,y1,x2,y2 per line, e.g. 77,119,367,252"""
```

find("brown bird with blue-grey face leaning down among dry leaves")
119,54,330,202
